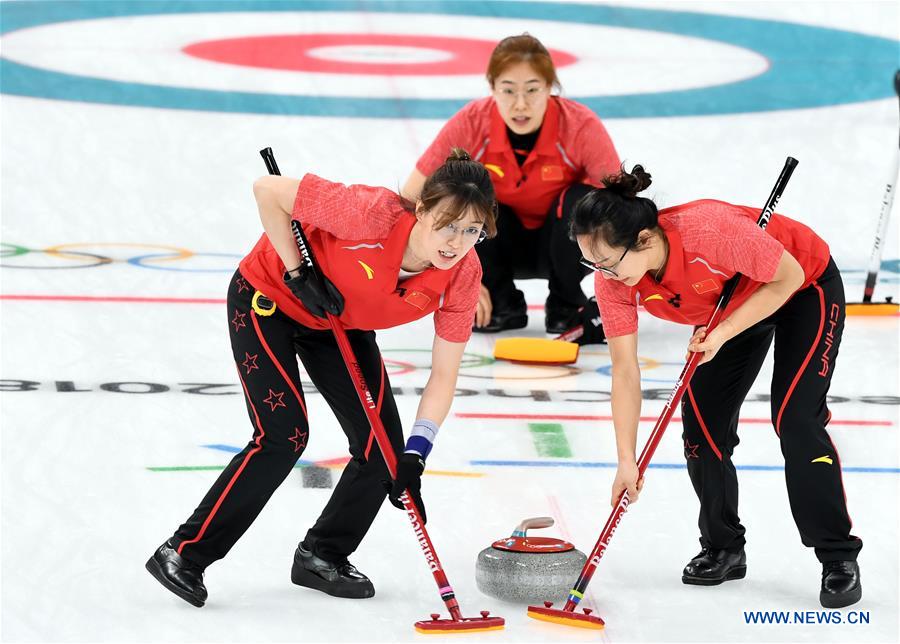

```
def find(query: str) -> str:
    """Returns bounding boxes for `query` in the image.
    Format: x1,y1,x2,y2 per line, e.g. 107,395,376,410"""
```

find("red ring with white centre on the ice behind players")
182,33,577,76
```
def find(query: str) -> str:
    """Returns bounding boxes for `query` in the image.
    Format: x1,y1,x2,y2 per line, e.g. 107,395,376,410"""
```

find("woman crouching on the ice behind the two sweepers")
403,34,619,343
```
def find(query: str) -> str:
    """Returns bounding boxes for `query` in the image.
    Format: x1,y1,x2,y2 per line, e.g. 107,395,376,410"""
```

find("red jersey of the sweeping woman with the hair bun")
594,199,831,337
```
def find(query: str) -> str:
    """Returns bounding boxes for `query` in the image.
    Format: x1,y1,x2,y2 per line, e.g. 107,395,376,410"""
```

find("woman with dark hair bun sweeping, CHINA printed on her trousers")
572,166,862,608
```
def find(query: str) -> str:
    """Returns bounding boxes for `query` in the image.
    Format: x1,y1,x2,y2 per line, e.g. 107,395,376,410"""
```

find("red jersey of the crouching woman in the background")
416,96,619,229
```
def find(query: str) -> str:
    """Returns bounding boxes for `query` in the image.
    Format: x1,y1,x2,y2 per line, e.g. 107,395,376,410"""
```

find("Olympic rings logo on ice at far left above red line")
0,242,243,273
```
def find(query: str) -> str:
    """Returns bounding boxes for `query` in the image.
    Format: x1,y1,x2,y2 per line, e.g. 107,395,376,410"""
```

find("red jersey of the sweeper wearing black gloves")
240,174,481,342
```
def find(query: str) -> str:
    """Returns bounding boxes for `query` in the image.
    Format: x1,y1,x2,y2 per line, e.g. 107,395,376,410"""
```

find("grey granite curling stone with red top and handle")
475,517,587,603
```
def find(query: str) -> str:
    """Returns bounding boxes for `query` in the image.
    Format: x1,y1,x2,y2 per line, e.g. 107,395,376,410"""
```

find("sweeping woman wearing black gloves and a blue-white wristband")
147,150,496,606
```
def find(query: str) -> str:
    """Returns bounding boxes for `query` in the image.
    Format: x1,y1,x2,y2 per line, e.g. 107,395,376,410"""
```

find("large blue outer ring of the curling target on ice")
0,0,898,119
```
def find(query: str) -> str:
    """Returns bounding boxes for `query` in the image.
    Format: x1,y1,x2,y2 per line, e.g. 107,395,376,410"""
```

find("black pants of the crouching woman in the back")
475,183,593,311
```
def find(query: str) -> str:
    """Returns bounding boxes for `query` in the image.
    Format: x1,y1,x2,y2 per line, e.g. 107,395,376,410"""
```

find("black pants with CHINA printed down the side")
681,260,862,562
